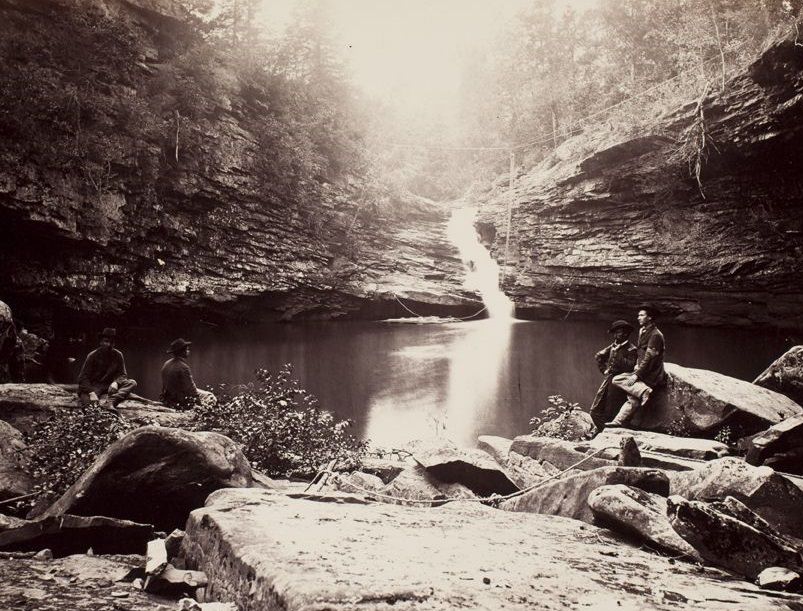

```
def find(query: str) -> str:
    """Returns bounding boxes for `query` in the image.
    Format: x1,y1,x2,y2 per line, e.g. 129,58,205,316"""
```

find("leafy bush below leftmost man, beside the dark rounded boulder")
25,406,139,495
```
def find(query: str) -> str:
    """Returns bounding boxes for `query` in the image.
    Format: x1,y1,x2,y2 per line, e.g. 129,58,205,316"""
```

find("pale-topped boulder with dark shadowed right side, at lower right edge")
671,457,803,538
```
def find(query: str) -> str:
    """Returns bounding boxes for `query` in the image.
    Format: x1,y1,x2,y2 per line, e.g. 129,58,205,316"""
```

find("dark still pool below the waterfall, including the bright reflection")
89,319,784,445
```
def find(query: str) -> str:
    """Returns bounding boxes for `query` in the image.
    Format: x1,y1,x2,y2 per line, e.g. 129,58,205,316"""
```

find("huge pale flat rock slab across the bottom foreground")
182,488,803,611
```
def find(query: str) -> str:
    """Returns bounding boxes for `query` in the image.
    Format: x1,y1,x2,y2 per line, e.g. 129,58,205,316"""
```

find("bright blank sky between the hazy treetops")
265,0,598,117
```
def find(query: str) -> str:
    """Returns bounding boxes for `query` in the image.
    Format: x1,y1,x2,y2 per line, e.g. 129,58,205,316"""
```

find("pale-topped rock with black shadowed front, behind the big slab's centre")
413,446,519,496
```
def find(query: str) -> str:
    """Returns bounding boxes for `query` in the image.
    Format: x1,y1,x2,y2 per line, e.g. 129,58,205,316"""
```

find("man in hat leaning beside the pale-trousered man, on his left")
591,320,636,431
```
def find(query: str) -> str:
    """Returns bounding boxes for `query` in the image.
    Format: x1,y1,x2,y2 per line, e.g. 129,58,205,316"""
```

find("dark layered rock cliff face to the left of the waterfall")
0,0,476,334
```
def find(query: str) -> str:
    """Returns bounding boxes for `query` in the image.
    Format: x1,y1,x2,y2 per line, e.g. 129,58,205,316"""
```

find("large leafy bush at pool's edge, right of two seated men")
196,364,367,477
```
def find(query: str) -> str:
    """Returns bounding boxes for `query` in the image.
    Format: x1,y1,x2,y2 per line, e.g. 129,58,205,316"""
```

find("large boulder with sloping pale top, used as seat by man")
630,363,803,436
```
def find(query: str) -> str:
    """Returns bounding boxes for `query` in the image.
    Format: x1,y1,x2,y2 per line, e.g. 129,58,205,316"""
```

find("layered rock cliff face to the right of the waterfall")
479,41,803,328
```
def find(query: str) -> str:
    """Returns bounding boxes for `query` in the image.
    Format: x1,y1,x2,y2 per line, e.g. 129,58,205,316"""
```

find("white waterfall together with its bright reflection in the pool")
366,208,513,446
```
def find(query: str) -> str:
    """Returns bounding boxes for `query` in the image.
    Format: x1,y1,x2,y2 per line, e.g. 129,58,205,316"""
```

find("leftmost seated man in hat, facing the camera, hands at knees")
78,327,137,407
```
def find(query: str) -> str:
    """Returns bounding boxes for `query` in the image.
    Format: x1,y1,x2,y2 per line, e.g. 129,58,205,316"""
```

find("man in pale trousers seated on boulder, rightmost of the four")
605,307,666,427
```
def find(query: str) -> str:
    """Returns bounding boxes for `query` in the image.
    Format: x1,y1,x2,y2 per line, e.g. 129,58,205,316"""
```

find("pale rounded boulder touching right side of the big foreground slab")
588,484,701,560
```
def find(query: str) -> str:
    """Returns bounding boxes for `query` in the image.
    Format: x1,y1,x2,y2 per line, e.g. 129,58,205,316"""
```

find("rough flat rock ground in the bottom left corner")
0,554,177,611
